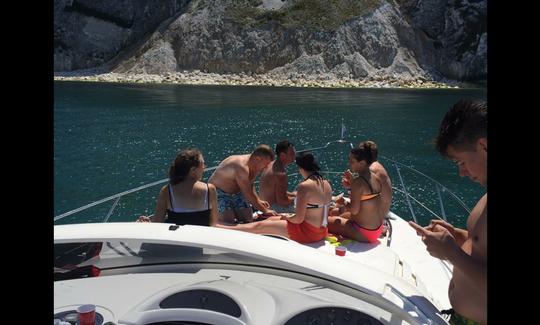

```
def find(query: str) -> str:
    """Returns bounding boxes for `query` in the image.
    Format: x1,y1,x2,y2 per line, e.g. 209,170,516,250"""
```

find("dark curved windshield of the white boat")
54,238,308,280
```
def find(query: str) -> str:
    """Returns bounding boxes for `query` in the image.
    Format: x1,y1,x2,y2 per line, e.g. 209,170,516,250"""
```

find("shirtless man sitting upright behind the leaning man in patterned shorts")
259,140,296,212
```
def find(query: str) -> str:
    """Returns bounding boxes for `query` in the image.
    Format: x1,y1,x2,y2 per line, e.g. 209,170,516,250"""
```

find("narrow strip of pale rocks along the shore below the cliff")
54,70,460,89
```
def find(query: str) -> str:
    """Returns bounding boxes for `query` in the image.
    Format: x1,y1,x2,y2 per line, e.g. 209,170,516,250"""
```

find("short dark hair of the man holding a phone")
435,100,487,156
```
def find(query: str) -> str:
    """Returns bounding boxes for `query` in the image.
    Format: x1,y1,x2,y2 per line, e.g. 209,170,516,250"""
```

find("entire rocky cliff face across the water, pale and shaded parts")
54,0,487,81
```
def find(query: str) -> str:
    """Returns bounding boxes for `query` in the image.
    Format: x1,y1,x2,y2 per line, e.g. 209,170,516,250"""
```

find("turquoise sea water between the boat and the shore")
54,81,487,226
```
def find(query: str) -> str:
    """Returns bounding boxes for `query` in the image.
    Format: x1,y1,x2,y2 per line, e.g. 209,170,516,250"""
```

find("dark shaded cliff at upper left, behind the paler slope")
54,0,189,71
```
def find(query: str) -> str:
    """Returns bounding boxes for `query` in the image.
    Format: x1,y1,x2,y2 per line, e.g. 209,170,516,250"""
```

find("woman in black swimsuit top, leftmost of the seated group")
137,148,217,226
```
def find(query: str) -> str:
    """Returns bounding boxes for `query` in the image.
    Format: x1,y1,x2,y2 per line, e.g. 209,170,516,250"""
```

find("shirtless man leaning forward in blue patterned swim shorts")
208,144,275,224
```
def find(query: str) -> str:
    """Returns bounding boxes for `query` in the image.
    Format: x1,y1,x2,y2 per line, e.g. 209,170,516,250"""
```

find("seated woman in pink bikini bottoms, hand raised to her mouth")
328,141,392,243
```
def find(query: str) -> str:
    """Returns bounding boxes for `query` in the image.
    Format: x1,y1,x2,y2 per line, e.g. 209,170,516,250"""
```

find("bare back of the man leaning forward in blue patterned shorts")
208,154,250,194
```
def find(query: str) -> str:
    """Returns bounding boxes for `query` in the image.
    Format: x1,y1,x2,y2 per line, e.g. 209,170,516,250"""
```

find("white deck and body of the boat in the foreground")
54,213,449,325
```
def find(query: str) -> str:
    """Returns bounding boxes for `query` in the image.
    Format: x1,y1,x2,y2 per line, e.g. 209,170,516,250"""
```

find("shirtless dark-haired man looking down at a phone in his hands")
409,101,487,324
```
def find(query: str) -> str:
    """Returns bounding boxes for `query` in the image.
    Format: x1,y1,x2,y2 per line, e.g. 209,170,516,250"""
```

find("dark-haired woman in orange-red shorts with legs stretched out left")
217,152,332,243
